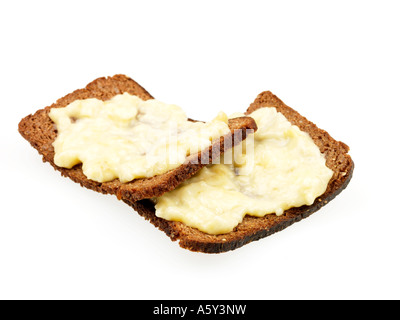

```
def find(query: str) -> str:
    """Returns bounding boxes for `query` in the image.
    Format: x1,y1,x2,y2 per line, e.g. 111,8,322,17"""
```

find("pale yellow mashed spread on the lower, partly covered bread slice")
155,108,333,234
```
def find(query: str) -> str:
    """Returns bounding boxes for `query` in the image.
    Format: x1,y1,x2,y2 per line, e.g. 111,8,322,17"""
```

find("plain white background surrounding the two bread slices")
0,0,400,299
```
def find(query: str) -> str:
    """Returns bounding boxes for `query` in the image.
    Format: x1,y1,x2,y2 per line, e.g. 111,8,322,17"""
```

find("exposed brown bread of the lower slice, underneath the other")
126,91,354,253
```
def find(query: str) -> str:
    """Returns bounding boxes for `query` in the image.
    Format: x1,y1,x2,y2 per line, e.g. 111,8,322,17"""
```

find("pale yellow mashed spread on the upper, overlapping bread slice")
49,93,230,183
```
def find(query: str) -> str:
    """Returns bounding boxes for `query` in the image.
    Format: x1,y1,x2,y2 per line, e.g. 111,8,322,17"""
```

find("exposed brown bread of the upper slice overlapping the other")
19,75,257,201
